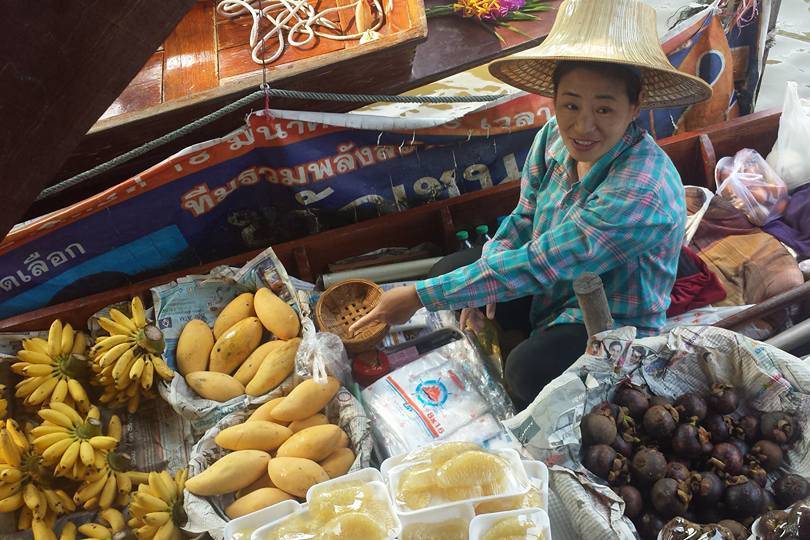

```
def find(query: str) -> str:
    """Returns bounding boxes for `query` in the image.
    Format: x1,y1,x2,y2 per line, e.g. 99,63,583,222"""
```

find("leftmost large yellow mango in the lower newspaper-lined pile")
186,450,270,497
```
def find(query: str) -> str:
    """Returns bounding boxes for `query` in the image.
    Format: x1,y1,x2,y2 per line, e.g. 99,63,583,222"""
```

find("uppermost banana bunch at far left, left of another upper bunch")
11,319,90,412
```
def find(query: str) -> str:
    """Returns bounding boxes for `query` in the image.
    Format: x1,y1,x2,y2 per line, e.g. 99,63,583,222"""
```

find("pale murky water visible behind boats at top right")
644,0,810,110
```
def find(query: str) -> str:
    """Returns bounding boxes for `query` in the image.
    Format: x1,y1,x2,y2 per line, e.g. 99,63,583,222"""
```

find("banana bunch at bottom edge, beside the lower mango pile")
128,469,188,540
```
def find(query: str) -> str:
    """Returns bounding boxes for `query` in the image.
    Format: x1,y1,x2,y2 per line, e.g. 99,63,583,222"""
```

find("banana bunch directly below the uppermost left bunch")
31,402,120,480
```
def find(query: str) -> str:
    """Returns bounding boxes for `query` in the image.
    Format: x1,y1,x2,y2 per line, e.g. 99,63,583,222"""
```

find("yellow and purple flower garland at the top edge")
425,0,552,43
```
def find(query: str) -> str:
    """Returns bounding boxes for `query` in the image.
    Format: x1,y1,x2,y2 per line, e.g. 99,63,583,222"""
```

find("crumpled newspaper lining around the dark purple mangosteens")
504,327,810,539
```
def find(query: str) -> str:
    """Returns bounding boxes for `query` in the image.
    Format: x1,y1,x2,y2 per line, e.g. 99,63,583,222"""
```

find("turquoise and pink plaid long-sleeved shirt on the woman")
416,119,686,335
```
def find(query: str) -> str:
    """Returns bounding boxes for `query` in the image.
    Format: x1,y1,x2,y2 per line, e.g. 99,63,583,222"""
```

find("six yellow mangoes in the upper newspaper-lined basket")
175,288,301,402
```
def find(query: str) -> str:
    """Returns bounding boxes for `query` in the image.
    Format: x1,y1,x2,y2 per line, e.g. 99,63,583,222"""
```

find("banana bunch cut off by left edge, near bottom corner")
0,419,76,530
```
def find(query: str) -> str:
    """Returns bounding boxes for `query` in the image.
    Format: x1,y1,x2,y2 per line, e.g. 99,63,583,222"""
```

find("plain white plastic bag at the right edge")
768,81,810,191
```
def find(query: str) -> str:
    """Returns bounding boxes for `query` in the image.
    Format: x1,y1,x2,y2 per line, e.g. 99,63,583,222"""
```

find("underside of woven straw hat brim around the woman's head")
489,56,712,109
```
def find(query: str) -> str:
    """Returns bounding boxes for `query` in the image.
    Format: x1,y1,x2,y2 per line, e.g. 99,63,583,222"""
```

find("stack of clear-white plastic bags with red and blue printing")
362,314,514,458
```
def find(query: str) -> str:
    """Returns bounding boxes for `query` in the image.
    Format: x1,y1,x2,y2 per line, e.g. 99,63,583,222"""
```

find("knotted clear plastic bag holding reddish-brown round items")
714,148,788,227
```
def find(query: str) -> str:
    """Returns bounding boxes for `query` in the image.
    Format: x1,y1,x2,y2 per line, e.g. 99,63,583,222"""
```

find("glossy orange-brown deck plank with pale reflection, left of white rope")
163,1,219,101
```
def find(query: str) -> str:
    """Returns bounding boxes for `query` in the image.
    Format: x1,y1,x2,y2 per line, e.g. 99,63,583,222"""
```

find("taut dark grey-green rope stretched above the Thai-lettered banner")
36,88,504,201
